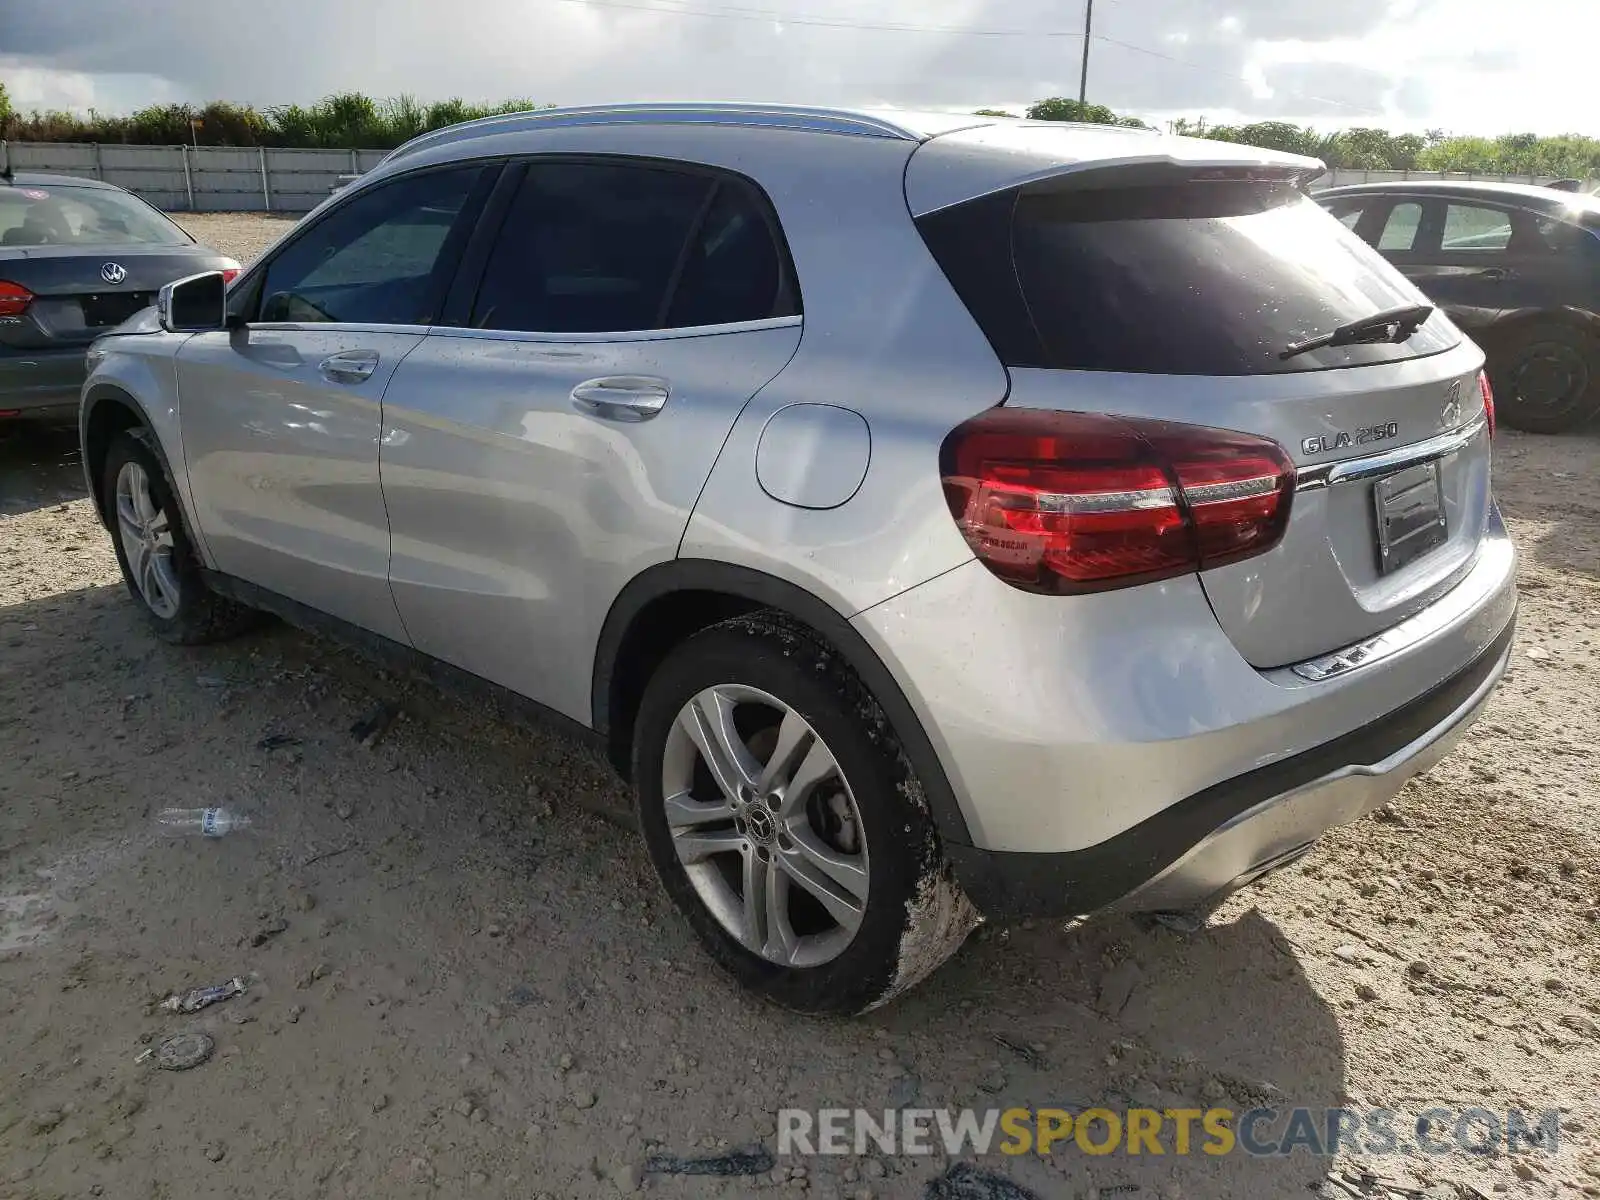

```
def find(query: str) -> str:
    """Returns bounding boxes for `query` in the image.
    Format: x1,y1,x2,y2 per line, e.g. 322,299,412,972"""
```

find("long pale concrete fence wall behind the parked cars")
0,141,1587,213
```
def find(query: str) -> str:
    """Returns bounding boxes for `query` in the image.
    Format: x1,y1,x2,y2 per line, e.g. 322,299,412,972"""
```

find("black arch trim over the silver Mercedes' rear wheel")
592,558,973,846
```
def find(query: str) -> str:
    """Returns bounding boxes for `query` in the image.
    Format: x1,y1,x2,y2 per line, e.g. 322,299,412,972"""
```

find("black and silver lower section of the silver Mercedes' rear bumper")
947,619,1515,918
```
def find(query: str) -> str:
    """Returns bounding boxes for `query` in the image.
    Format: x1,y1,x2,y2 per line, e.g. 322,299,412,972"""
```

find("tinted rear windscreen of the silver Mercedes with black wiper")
918,181,1456,376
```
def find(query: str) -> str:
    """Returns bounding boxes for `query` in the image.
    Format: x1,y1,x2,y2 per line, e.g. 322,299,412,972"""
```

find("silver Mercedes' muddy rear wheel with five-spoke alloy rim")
634,613,979,1016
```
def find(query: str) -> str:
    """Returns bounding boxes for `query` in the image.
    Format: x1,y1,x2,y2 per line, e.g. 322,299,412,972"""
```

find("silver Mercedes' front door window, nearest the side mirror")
259,166,482,325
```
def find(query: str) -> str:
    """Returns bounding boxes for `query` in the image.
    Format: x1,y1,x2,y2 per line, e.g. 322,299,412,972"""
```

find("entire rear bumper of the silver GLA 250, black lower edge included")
853,510,1517,917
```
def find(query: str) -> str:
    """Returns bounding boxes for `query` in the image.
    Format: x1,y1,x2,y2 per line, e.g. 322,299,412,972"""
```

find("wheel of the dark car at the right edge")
1490,325,1600,434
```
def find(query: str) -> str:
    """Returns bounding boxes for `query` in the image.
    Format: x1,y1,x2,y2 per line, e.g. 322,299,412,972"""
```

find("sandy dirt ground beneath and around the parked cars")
0,216,1600,1200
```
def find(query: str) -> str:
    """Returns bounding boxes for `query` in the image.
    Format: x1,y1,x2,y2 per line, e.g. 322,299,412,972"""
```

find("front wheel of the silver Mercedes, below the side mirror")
101,429,262,646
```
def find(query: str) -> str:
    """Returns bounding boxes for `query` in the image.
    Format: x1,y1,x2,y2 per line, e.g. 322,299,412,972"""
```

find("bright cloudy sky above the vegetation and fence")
0,0,1600,133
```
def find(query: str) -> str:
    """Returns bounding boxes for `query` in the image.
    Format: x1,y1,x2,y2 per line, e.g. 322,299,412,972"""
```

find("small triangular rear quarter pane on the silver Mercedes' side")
664,181,800,330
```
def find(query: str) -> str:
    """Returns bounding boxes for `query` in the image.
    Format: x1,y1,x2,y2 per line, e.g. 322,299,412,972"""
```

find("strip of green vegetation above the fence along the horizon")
0,83,1600,178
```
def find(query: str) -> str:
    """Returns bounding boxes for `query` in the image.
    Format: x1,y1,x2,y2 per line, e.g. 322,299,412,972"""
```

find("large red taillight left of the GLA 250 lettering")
941,408,1294,594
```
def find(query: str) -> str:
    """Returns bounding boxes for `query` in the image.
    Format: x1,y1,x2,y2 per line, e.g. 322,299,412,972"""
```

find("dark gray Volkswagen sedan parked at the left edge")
0,173,238,421
